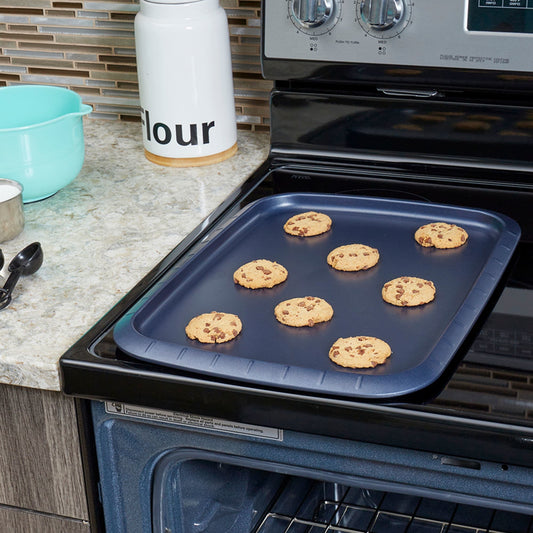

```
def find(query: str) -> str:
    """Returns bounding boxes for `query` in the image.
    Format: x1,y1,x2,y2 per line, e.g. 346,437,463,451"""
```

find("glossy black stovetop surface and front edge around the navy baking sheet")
60,156,533,464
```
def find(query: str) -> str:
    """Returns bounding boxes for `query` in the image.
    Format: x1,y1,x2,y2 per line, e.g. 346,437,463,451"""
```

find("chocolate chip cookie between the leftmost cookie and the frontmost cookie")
274,296,333,328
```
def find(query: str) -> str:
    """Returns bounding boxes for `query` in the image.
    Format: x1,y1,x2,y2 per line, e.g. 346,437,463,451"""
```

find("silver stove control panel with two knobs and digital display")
263,0,533,72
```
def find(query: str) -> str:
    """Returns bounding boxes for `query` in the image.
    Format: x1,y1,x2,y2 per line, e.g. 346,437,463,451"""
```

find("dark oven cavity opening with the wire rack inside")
152,459,533,533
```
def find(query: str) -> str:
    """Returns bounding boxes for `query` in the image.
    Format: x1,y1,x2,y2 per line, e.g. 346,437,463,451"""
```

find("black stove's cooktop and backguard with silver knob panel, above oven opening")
60,0,533,476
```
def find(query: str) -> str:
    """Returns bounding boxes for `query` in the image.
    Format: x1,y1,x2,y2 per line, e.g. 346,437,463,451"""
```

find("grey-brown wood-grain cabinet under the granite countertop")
0,385,90,533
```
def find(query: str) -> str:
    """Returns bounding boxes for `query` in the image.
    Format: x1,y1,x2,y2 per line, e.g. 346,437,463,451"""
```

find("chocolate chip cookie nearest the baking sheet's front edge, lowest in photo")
329,335,392,368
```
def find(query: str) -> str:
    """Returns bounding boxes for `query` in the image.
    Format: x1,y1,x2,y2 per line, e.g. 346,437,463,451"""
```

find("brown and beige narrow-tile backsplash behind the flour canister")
0,0,272,131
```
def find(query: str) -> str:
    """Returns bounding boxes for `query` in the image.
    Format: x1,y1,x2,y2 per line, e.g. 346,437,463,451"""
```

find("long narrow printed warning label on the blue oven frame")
101,402,283,441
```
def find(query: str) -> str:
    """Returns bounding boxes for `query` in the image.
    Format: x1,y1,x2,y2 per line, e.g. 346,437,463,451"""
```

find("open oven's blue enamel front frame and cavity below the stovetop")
91,402,533,533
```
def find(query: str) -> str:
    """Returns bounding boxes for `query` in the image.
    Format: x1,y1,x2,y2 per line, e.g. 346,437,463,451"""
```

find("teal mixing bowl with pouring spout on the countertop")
0,85,92,203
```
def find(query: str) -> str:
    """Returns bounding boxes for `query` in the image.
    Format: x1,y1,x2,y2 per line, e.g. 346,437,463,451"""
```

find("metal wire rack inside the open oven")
252,480,533,533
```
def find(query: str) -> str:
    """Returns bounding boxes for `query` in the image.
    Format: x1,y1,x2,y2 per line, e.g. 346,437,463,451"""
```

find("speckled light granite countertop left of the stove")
0,118,269,390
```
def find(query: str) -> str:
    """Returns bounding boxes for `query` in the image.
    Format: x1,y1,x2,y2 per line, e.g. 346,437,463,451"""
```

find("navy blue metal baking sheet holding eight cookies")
114,194,520,399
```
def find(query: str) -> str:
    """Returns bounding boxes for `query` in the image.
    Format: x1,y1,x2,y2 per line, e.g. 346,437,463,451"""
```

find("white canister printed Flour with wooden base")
135,0,237,167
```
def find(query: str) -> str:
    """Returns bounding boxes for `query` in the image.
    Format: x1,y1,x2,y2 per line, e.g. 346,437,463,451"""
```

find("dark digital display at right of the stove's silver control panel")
467,0,533,34
